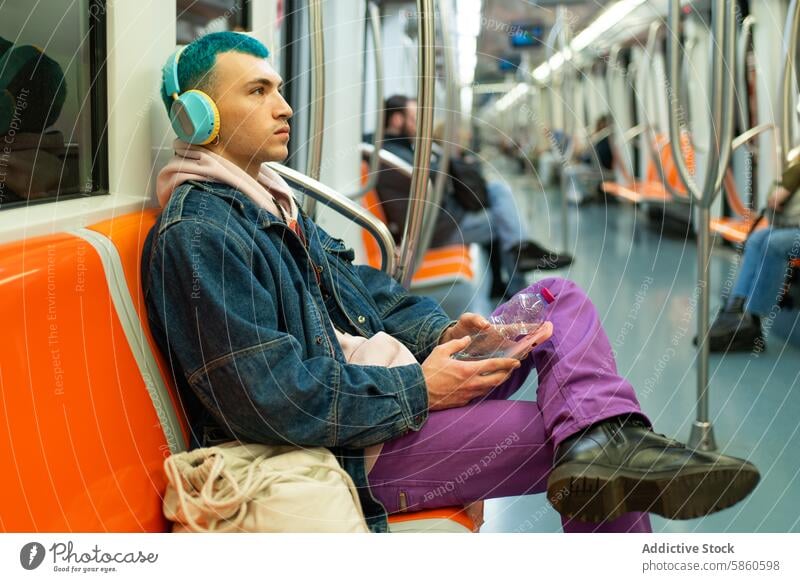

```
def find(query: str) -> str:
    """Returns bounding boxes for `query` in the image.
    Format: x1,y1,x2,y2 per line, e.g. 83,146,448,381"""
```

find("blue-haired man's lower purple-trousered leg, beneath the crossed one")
368,400,651,532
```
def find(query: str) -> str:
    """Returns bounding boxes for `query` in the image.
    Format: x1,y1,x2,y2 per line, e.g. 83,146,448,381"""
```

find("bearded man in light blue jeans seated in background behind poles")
378,95,572,280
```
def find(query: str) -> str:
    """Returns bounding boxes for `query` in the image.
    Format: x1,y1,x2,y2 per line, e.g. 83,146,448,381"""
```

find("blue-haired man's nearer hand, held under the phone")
422,336,521,411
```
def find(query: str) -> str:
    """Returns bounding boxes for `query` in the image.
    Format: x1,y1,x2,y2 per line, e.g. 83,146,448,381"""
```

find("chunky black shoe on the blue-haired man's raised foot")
547,417,759,522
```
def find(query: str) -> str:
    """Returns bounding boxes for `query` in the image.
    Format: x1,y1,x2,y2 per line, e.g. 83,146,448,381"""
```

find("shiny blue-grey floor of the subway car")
482,155,800,532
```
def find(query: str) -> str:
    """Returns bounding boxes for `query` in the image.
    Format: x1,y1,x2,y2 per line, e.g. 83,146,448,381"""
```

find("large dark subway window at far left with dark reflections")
0,0,107,210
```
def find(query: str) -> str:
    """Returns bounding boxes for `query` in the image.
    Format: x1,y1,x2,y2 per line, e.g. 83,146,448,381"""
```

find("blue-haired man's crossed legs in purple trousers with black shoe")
369,278,758,532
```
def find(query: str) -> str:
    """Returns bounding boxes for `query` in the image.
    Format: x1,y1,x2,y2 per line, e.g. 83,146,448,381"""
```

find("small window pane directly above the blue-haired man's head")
177,0,250,44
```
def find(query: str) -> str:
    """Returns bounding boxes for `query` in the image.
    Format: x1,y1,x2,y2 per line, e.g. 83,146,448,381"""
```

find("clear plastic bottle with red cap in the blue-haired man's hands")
453,287,555,360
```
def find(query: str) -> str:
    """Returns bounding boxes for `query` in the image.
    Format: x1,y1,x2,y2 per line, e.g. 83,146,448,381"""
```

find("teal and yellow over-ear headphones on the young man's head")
163,49,219,145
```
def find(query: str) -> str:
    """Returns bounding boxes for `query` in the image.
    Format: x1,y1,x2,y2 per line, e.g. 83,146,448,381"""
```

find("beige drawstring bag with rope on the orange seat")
164,441,369,533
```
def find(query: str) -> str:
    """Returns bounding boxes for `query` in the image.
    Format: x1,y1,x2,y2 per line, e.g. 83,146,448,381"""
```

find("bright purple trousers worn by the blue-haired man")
369,278,652,532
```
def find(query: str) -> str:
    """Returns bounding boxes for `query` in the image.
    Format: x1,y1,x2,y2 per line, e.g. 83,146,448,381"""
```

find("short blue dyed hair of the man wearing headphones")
161,32,269,113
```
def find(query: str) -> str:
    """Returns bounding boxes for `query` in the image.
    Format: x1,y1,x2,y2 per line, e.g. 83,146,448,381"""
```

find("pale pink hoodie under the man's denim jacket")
156,139,417,473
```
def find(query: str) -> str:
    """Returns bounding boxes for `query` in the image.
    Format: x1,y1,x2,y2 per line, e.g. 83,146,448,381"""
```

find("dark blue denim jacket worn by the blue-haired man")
142,182,452,532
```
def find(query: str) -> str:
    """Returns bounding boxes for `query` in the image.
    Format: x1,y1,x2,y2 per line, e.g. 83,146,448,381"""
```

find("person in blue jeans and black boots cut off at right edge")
708,159,800,352
